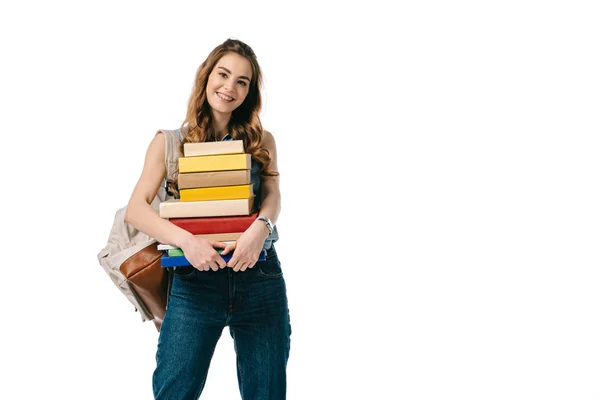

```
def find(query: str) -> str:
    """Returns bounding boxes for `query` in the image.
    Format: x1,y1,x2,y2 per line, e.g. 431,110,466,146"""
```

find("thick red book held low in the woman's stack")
169,213,258,235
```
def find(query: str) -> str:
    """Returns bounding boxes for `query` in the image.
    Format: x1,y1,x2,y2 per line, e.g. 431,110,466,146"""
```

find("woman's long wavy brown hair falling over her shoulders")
180,39,279,176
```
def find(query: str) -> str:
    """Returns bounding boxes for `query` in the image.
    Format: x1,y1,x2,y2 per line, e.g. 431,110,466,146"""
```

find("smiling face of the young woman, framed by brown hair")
206,53,252,114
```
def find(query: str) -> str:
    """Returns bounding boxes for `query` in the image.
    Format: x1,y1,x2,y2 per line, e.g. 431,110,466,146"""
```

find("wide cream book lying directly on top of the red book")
158,197,254,218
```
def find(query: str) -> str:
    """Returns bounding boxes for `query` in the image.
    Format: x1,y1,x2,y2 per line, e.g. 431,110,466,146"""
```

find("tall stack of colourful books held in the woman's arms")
158,140,264,267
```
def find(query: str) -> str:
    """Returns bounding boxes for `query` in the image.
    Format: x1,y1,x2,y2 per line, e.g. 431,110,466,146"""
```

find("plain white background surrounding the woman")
0,1,600,400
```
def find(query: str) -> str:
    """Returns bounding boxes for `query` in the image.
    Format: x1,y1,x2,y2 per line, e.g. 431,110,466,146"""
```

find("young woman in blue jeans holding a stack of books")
126,39,291,400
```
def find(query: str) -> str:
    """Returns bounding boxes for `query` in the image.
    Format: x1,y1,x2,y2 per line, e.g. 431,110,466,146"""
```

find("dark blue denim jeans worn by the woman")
152,247,291,400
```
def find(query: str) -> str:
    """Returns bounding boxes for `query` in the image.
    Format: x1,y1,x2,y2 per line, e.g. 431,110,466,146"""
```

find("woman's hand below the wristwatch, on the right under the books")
221,221,269,272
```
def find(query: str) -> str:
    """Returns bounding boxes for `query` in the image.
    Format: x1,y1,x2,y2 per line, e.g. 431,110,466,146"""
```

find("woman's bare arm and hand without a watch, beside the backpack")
125,133,226,270
